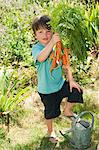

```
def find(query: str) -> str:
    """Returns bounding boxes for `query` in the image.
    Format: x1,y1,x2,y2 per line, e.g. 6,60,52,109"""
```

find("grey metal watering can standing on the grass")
60,111,94,150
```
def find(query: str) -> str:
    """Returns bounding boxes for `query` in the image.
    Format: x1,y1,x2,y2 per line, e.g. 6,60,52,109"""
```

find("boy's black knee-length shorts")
39,81,83,119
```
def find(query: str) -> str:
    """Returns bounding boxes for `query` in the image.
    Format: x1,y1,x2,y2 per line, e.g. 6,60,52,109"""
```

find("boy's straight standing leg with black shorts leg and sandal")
39,92,62,143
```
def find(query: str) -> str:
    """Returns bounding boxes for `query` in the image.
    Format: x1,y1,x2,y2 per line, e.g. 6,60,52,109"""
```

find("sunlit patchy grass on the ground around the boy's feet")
0,89,99,150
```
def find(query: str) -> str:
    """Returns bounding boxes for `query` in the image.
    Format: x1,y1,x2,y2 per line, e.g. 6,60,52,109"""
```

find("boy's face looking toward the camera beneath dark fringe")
35,28,53,46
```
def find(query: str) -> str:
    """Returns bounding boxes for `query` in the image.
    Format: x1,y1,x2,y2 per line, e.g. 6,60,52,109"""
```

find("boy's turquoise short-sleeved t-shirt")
32,43,65,94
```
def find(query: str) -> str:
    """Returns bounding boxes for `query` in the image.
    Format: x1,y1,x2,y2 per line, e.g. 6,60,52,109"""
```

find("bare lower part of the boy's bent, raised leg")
64,102,75,116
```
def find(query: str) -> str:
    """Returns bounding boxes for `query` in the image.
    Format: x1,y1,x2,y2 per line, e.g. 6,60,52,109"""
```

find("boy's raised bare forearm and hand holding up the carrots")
37,33,60,62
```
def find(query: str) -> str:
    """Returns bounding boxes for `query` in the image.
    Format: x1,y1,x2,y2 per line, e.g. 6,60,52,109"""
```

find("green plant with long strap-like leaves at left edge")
0,69,31,112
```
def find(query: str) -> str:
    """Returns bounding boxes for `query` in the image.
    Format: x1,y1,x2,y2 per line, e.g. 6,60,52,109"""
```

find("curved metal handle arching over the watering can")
74,111,94,128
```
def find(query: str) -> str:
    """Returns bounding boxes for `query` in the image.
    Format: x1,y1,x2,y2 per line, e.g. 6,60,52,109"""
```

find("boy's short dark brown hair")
32,15,51,34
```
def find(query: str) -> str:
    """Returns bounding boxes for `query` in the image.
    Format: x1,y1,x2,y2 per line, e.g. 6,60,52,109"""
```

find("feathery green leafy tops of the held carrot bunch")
50,1,91,61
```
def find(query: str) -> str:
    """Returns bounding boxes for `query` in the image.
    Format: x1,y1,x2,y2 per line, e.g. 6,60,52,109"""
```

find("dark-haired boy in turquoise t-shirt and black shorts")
32,15,83,143
